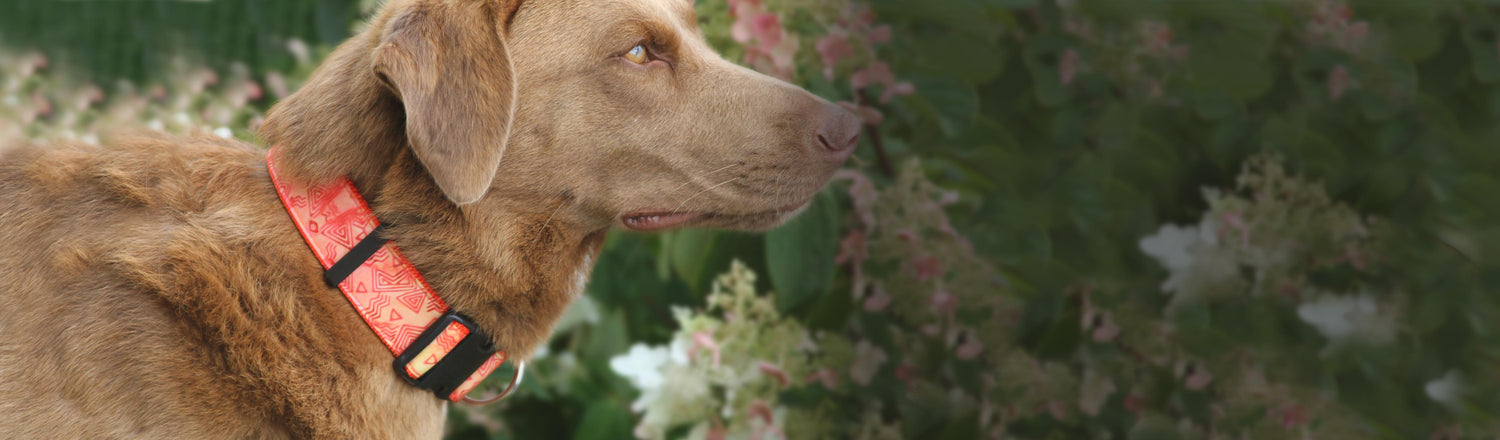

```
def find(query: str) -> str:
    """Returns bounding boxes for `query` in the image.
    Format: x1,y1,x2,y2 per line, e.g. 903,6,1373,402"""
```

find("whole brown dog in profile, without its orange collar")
0,0,858,438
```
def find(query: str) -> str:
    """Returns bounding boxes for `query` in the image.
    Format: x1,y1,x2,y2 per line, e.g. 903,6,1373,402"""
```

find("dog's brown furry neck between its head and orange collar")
261,34,606,357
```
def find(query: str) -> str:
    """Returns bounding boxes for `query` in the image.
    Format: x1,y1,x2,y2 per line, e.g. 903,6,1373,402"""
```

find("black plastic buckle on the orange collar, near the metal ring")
392,311,497,399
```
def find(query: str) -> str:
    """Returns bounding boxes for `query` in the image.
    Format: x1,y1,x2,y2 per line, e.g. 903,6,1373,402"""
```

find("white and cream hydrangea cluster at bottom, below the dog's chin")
609,261,819,440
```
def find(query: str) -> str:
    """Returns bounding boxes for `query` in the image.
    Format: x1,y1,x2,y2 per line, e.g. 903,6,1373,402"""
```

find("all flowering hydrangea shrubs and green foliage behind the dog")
0,0,1500,438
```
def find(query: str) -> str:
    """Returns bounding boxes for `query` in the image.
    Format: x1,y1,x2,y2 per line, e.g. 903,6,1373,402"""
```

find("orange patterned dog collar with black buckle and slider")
266,149,525,404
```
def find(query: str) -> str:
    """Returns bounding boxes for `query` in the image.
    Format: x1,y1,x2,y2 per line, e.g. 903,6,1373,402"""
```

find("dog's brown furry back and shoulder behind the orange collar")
0,135,441,438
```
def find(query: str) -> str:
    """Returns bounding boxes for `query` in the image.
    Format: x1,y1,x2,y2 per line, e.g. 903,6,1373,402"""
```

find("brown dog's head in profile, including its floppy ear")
264,0,860,230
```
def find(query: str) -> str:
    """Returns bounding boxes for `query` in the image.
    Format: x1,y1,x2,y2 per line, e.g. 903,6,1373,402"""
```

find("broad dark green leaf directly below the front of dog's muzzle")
765,191,839,312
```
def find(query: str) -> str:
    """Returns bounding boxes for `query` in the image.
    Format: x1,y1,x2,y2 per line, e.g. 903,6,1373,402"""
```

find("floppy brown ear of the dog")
371,0,519,204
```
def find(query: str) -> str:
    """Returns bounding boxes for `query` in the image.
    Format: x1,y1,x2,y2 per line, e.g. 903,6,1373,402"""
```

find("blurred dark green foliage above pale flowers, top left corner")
0,0,360,81
